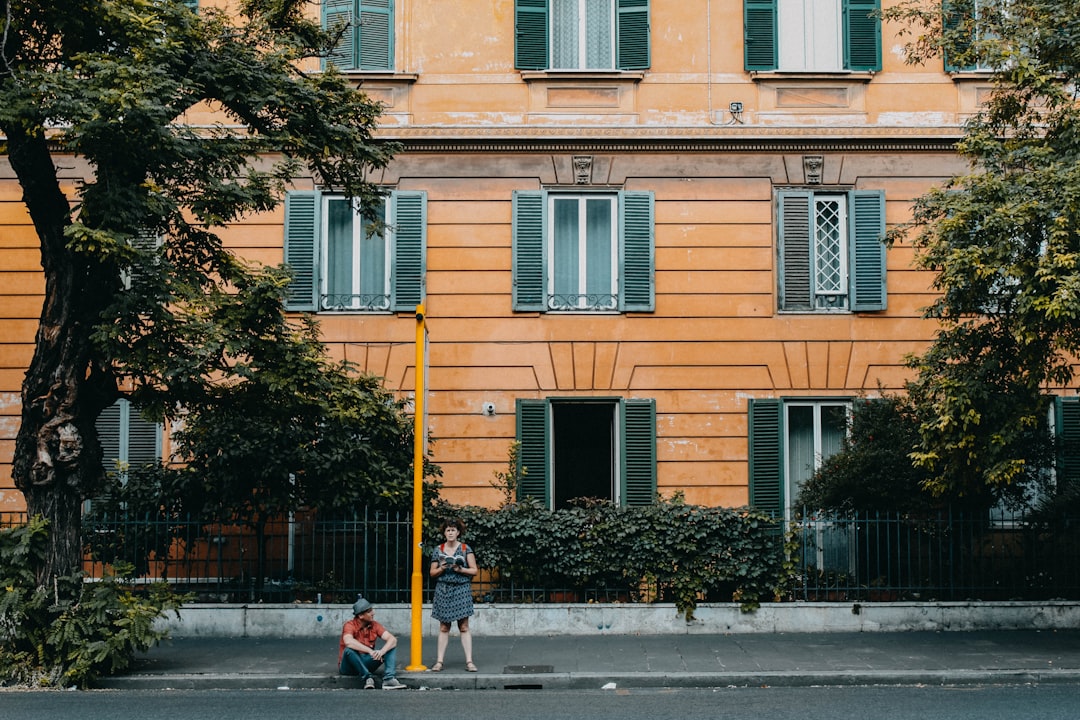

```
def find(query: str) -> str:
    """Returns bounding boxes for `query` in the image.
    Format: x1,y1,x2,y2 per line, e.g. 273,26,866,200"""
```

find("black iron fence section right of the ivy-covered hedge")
788,511,1080,601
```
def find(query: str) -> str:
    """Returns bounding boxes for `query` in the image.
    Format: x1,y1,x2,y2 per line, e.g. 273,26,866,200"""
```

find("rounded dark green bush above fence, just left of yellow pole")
174,337,423,519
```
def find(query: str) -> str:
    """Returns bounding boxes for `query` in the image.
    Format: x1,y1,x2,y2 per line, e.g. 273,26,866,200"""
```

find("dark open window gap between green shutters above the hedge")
551,403,618,510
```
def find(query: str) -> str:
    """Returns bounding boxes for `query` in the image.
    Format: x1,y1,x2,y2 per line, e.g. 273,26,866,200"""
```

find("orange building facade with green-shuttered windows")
0,0,1019,518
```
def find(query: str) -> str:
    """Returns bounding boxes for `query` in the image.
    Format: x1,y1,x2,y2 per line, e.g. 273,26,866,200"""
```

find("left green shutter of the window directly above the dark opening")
512,190,548,312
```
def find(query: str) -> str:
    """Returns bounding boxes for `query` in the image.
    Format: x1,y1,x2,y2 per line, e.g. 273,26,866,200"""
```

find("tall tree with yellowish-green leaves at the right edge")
883,0,1080,493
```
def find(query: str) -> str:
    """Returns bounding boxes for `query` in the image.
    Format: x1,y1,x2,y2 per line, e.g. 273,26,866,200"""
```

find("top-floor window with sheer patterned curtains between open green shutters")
514,0,649,70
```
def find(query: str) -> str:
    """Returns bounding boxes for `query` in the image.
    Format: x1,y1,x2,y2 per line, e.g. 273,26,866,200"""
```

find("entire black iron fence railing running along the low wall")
6,511,1080,602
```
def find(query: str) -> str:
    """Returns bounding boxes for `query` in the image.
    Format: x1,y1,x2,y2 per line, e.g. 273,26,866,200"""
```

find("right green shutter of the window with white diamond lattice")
848,190,888,312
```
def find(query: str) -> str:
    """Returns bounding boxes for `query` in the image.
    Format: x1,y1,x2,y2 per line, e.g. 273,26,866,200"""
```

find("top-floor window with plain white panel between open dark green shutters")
743,0,881,72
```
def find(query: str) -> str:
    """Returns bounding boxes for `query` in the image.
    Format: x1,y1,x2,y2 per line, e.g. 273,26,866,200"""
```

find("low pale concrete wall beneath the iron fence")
162,601,1080,638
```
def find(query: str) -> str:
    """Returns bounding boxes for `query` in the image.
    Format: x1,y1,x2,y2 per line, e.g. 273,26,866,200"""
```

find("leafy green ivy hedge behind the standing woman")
428,497,786,620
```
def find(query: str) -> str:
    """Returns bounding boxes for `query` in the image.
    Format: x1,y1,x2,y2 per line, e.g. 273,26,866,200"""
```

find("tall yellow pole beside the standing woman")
405,304,428,673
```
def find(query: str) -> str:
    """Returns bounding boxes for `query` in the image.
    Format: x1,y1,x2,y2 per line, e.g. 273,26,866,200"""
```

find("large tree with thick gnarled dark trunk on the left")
0,0,394,582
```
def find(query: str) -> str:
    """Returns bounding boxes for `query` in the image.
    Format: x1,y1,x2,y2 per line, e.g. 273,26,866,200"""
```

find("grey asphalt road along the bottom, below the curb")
0,684,1080,720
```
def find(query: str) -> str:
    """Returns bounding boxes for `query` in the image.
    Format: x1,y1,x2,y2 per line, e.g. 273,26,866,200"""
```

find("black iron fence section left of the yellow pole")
83,511,413,602
